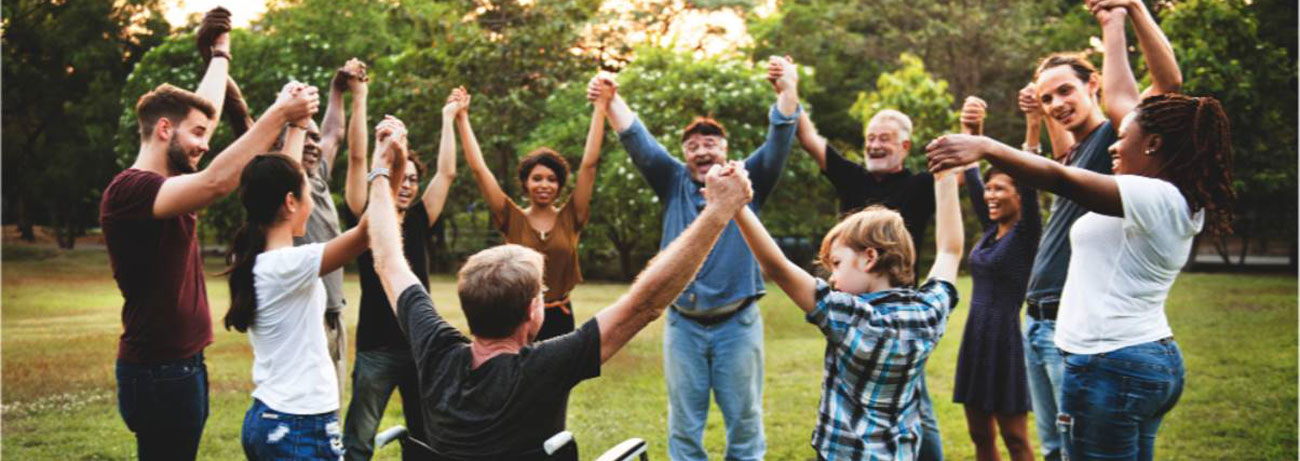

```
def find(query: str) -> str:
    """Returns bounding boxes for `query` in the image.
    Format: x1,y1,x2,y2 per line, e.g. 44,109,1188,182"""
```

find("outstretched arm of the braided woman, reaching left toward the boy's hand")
926,135,1123,219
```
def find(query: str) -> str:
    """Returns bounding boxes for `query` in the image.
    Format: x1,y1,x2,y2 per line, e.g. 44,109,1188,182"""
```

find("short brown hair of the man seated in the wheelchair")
456,244,543,338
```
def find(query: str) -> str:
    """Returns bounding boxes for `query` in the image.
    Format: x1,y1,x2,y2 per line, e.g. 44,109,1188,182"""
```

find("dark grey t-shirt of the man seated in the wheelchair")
398,286,601,460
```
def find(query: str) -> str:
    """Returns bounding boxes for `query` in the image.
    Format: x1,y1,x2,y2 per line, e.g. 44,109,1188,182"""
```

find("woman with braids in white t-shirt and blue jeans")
927,0,1235,460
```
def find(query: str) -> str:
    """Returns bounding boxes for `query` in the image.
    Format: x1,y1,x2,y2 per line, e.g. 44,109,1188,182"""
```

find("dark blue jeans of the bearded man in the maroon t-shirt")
117,352,208,460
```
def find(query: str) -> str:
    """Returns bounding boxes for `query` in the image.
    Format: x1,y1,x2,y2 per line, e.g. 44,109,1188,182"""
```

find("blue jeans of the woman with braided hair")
1057,339,1186,461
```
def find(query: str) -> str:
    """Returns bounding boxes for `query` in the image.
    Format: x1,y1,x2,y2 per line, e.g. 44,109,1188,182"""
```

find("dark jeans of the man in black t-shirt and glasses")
343,349,432,460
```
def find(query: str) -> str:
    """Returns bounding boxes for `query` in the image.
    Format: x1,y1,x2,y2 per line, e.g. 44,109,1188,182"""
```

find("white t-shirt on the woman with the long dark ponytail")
248,243,339,414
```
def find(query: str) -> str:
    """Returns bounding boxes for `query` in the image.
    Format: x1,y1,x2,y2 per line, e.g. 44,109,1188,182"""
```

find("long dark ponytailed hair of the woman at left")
225,153,303,332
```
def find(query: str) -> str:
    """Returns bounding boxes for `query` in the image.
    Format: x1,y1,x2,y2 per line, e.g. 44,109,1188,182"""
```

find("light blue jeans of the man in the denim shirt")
663,304,767,460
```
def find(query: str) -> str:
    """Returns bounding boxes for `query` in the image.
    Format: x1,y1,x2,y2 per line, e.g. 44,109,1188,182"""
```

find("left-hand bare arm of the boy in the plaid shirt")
736,206,816,312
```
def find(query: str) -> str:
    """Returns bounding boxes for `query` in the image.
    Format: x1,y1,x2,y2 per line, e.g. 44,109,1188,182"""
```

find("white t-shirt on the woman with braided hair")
1056,175,1205,355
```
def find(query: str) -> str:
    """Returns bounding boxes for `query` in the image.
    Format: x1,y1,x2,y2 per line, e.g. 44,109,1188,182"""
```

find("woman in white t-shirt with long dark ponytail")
225,114,406,460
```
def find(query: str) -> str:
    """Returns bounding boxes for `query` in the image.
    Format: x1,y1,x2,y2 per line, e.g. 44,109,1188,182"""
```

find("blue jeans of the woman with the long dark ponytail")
241,399,343,461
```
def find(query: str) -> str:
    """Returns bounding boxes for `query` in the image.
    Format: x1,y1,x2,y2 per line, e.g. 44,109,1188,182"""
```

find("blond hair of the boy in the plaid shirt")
818,205,917,287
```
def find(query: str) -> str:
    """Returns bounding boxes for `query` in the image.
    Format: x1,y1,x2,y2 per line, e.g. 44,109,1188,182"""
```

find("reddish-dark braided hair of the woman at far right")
1136,93,1236,236
